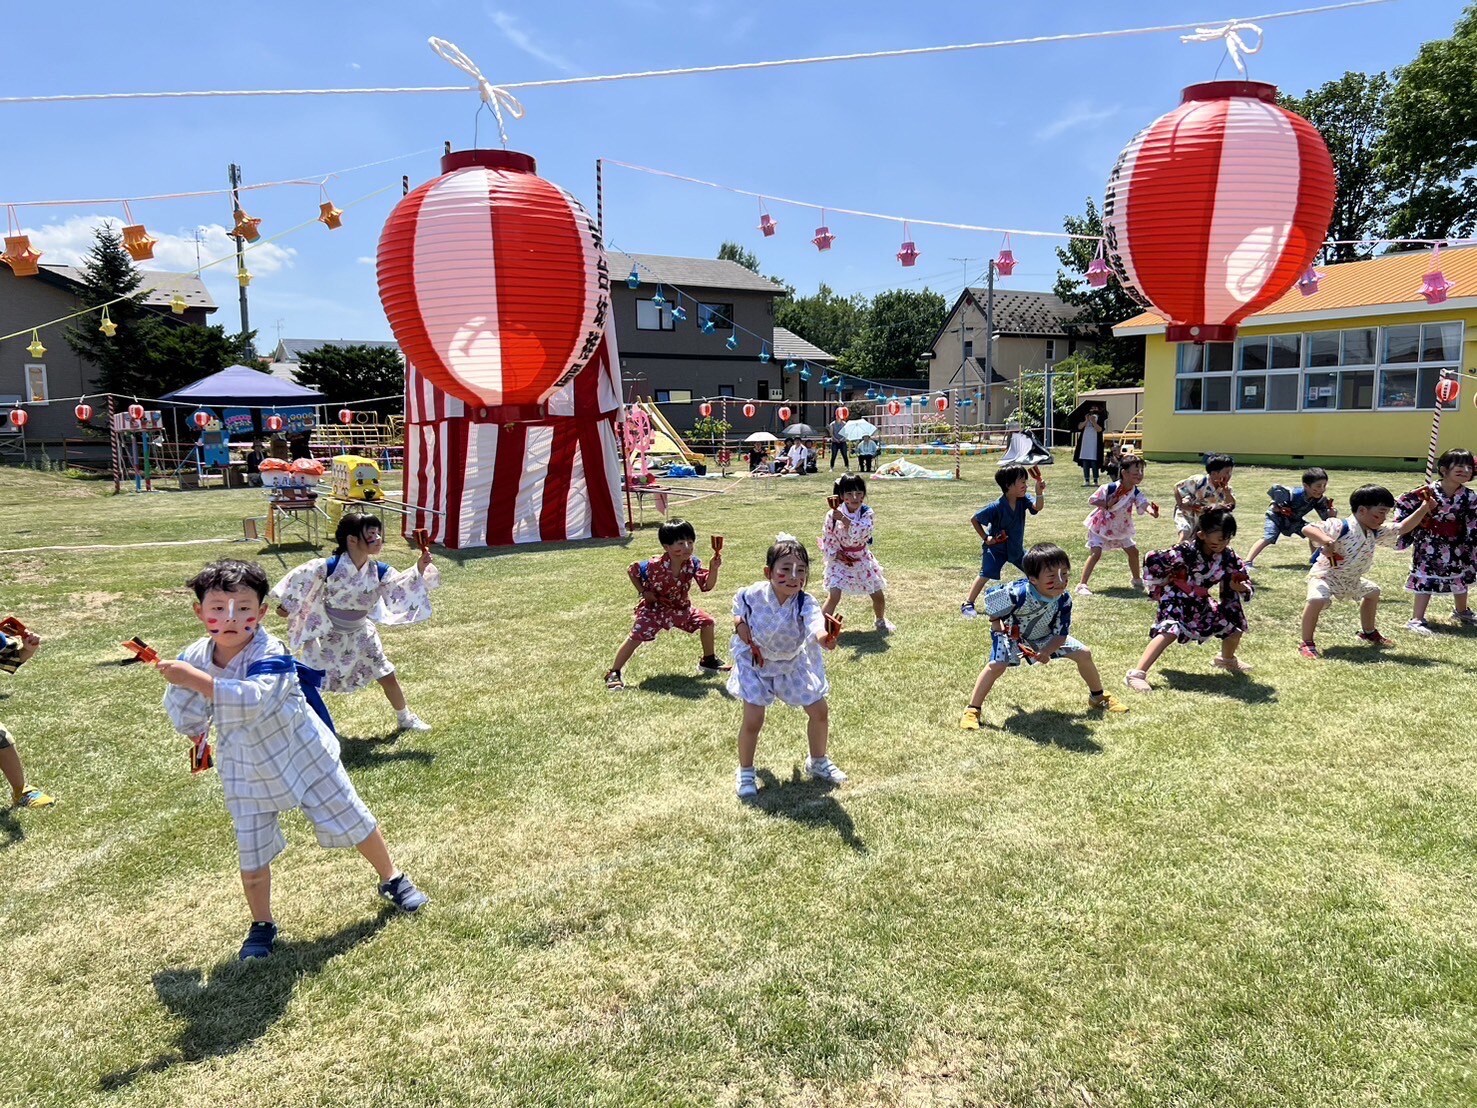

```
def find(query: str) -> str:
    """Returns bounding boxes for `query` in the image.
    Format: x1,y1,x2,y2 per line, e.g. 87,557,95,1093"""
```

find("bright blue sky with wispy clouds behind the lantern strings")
0,0,1462,352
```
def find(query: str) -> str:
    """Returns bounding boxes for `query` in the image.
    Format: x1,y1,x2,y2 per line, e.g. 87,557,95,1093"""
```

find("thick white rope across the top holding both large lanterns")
0,0,1393,103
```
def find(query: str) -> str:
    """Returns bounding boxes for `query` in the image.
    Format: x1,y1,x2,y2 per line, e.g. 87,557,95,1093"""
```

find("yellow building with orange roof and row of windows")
1114,247,1477,468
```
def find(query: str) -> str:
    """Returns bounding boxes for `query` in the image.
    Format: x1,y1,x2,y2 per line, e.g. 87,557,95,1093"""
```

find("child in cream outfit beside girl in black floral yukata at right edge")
1298,485,1431,659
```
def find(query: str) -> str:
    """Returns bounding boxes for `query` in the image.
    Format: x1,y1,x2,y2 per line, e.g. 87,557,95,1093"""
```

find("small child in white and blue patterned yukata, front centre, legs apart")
728,532,846,801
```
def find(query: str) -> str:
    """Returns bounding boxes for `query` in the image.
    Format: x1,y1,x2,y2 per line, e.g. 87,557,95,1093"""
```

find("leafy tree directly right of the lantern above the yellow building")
1278,72,1390,263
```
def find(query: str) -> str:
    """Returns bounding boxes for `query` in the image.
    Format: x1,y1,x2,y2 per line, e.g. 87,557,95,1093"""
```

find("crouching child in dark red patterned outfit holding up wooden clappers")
606,519,730,693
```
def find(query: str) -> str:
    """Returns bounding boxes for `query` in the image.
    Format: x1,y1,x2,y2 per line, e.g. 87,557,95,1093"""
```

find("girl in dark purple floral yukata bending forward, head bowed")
1124,508,1252,693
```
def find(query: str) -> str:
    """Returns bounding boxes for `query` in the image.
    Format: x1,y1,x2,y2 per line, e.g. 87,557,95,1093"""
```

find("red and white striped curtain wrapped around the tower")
405,328,625,550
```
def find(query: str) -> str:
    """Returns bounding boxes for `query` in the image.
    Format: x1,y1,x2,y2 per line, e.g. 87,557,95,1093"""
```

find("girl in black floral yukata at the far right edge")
1394,449,1477,635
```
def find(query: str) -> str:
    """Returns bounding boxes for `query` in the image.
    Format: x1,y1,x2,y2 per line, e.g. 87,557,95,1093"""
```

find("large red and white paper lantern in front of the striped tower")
378,149,610,406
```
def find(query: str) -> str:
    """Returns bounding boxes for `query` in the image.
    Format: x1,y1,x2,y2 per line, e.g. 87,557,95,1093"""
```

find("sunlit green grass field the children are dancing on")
0,459,1477,1108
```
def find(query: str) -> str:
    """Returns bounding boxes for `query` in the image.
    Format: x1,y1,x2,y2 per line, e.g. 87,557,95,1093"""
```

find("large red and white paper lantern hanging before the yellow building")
1103,81,1337,343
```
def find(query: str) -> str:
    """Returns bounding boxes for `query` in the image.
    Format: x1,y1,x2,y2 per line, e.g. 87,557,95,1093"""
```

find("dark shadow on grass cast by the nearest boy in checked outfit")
97,906,396,1092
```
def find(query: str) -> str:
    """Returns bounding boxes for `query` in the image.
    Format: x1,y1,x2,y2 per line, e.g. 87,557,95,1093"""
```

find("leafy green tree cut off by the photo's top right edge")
1380,4,1477,239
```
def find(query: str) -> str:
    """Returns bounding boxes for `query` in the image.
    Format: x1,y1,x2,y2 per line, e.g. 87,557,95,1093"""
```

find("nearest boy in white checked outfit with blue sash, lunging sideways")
158,561,427,962
